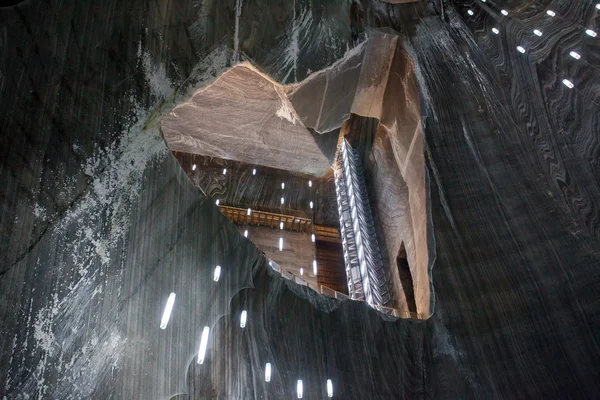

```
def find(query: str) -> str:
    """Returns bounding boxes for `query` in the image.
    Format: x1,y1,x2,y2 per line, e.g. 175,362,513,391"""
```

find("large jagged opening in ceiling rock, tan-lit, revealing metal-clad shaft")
161,34,431,319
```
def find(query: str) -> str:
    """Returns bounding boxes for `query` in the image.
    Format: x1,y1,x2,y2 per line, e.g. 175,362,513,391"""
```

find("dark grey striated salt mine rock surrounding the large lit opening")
0,0,600,399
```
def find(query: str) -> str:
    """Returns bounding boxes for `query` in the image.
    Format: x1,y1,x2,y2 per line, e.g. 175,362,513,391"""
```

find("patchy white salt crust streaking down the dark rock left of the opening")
3,40,227,398
